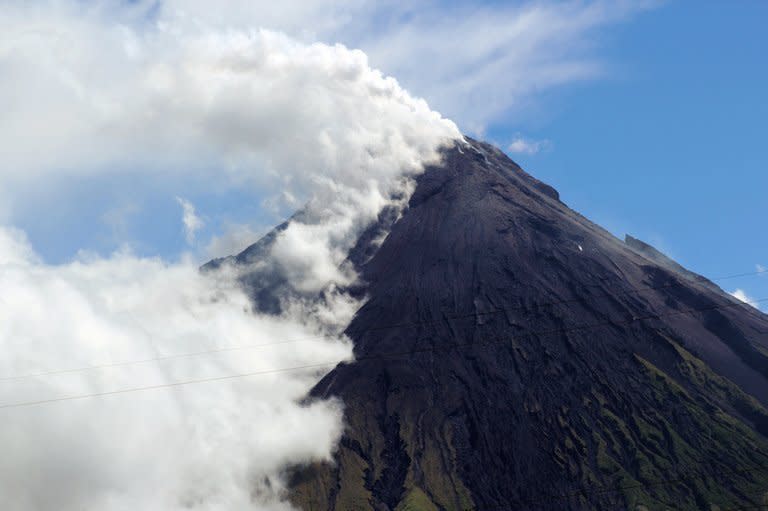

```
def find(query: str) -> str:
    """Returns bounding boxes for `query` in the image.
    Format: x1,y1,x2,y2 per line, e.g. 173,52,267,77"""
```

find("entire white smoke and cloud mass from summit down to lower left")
0,2,460,511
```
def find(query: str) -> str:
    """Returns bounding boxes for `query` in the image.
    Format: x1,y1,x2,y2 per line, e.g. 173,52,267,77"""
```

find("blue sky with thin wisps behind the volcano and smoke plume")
10,0,768,306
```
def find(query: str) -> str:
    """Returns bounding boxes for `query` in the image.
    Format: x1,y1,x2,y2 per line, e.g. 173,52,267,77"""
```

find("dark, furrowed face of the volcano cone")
213,140,768,511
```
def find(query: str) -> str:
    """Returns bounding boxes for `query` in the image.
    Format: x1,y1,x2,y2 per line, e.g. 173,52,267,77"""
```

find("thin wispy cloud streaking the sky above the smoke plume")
3,0,662,140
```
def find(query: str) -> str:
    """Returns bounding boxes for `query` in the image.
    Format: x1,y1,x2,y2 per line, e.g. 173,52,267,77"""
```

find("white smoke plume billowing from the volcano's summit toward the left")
0,5,460,292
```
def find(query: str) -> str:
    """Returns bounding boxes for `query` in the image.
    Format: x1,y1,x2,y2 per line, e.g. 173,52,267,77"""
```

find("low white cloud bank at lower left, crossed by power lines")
0,229,354,511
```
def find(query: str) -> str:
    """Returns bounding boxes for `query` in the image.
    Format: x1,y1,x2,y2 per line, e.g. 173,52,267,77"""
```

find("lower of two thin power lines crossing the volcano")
0,298,768,409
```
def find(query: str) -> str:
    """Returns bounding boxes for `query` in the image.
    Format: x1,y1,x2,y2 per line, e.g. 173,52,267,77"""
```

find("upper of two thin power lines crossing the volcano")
0,269,768,382
